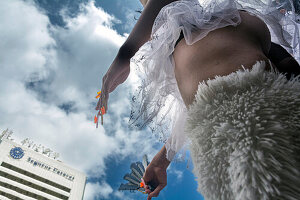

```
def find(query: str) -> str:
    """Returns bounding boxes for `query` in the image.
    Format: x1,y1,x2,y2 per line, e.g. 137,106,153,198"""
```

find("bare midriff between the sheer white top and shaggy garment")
173,11,271,107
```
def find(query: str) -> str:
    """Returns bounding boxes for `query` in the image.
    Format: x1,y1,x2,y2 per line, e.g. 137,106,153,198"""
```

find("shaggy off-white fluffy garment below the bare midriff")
185,62,300,200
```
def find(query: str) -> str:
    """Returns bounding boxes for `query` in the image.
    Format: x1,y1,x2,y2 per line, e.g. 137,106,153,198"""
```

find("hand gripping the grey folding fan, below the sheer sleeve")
143,163,167,200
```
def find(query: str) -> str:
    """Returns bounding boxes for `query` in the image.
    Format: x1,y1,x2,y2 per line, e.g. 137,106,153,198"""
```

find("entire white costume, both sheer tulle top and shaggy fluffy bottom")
129,0,300,200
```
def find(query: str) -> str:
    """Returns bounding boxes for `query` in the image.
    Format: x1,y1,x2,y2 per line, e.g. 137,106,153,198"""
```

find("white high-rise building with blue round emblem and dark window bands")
0,132,86,200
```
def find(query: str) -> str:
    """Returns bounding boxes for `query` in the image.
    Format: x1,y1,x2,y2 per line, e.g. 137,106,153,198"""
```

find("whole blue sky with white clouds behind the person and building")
0,0,203,200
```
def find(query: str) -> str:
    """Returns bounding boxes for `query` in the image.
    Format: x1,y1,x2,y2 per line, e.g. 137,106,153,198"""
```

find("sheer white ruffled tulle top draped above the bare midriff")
129,0,300,160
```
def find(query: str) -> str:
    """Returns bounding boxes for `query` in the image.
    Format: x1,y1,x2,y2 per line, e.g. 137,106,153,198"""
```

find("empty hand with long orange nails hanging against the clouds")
96,56,130,125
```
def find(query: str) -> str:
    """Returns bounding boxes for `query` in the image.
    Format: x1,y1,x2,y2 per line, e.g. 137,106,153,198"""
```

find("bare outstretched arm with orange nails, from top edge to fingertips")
96,0,177,125
